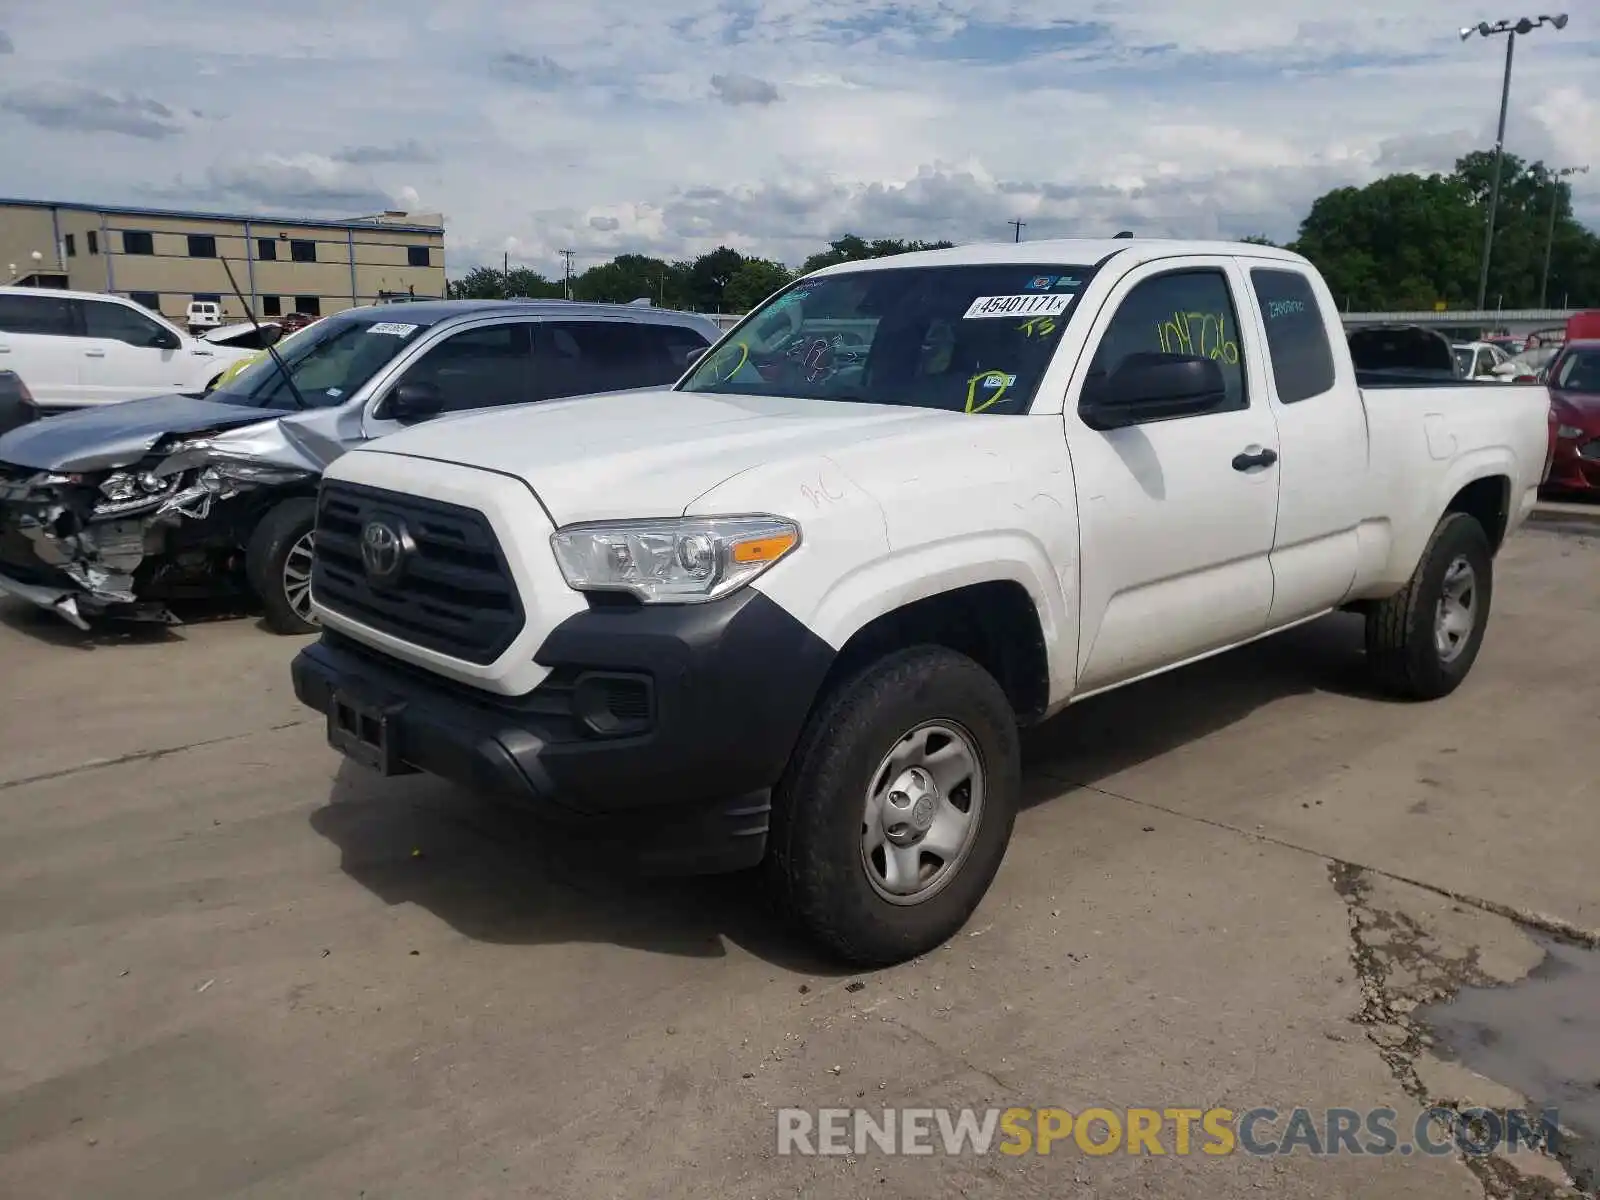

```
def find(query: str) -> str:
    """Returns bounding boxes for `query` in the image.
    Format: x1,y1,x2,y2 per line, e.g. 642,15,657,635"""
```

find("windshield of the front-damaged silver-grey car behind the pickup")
206,317,427,408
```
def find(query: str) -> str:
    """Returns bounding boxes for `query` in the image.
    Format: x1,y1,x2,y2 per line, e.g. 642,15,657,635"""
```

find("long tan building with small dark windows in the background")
0,198,445,323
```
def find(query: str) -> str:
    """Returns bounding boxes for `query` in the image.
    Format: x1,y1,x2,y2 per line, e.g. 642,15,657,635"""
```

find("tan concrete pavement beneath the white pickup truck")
0,534,1600,1200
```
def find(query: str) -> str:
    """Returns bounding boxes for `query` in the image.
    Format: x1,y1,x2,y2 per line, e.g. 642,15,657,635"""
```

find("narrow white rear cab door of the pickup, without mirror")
1240,259,1370,627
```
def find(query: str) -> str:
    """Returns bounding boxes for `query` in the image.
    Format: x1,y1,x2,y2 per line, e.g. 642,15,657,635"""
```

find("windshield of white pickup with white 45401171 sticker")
678,264,1093,414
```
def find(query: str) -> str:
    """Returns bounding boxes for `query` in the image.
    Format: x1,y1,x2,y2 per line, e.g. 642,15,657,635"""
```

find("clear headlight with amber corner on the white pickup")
550,517,800,605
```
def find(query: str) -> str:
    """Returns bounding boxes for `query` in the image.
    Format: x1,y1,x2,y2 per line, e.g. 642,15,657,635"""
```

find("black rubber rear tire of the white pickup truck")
1366,512,1494,699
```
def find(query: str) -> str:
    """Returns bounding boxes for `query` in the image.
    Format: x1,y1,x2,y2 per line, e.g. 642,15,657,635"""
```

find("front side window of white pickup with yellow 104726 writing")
1086,269,1250,413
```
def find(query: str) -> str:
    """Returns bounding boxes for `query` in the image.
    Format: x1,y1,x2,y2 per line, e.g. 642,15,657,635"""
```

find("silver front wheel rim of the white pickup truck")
861,722,984,904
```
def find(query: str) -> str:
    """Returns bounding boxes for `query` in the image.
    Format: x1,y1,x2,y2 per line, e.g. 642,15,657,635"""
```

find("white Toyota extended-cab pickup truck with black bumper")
293,240,1549,965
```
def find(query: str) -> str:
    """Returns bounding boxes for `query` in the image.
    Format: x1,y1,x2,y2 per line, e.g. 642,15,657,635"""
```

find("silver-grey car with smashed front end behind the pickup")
0,301,720,634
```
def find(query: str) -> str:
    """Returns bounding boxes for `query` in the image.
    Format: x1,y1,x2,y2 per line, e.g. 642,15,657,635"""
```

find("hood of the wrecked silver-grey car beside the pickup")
0,395,283,470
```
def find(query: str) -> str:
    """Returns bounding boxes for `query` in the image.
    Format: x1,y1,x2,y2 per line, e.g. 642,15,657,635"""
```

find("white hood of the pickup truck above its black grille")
352,389,972,525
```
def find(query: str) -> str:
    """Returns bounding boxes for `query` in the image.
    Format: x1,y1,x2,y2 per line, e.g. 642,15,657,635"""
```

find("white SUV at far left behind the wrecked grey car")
0,288,253,408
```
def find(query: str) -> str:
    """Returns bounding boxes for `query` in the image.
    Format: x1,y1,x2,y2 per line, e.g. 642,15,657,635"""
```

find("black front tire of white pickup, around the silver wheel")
763,646,1021,966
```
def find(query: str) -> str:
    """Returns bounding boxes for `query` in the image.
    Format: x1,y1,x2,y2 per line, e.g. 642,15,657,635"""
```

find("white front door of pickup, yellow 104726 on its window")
1066,256,1278,691
